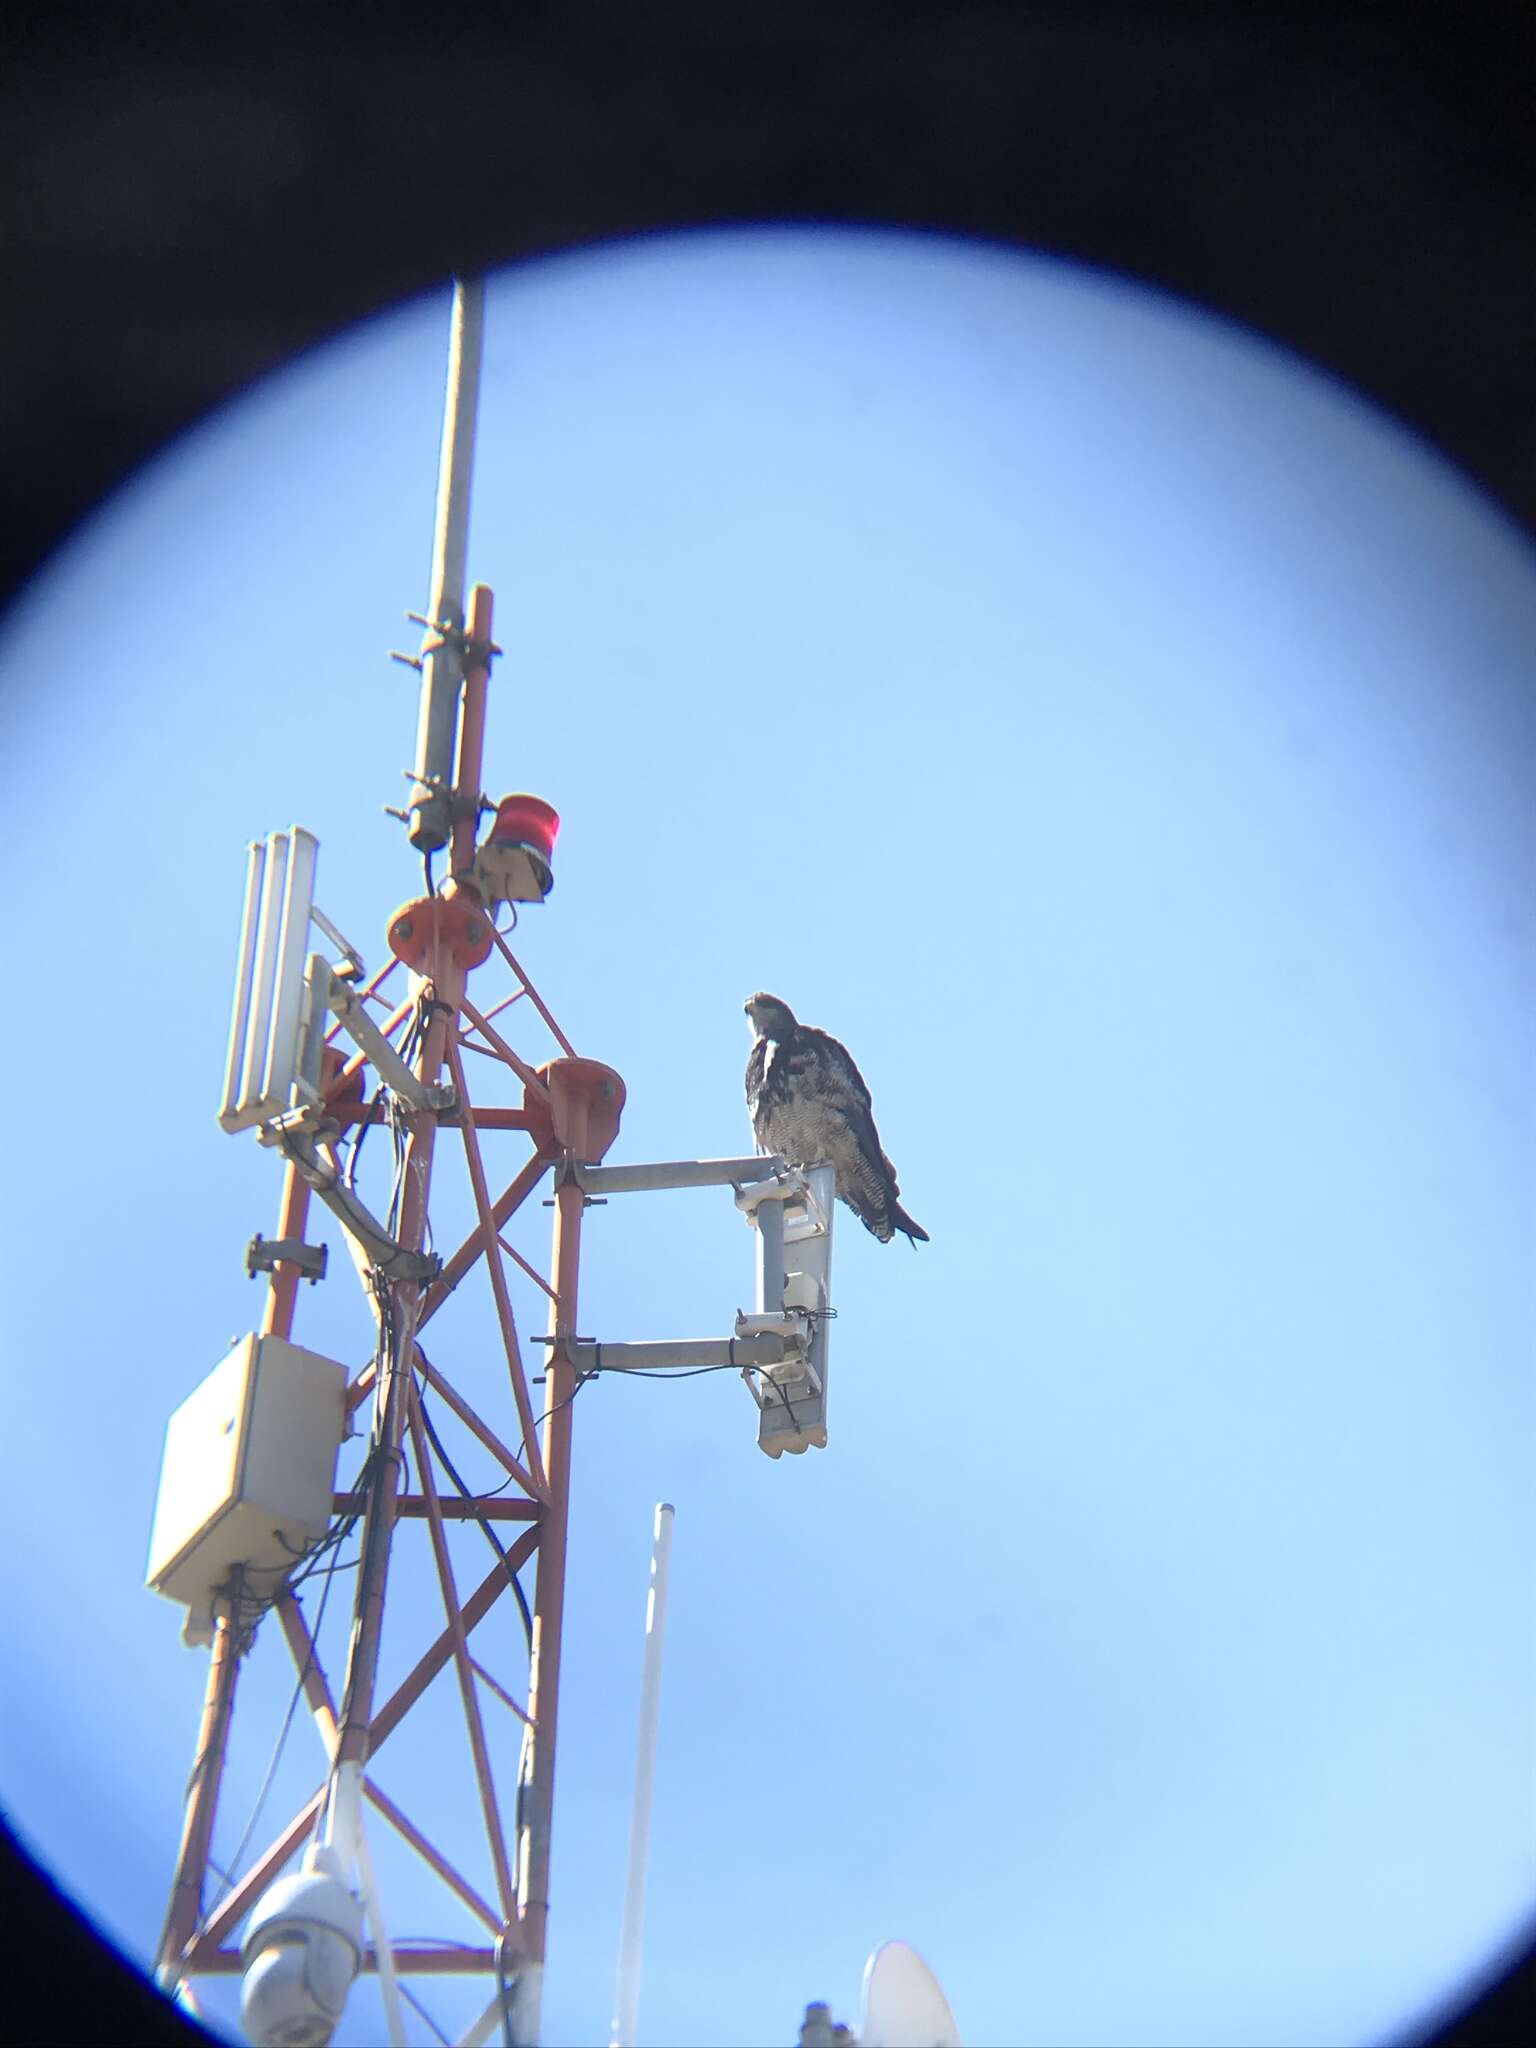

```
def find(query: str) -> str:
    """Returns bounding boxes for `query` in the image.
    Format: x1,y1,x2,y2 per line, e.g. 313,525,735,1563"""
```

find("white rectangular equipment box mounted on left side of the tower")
147,1333,346,1642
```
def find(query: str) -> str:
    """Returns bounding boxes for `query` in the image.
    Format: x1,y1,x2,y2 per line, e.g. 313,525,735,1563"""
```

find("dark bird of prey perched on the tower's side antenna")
743,993,928,1245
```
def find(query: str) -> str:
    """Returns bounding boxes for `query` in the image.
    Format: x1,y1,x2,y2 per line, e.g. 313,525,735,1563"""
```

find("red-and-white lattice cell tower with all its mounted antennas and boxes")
150,283,836,2048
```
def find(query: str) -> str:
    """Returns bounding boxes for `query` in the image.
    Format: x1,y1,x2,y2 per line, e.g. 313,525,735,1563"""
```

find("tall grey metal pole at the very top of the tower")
410,279,485,854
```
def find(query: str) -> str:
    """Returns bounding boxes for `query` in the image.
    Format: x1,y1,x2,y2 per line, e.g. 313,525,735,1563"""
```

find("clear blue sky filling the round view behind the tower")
0,229,1536,2048
